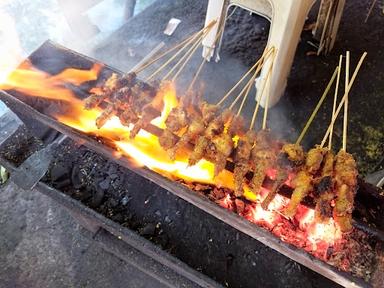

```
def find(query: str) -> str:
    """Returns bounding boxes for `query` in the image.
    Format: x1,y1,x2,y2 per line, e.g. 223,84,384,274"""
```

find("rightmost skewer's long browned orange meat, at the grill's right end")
333,150,358,232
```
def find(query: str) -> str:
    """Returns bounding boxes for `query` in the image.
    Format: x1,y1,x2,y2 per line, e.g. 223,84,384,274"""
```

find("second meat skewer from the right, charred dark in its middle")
315,150,335,222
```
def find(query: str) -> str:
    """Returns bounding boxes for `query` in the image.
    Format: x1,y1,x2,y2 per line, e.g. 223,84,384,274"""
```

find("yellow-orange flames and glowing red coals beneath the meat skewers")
0,61,348,270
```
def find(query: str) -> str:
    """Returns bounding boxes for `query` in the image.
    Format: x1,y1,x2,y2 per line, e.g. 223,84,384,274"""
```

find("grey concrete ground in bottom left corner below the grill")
0,183,165,288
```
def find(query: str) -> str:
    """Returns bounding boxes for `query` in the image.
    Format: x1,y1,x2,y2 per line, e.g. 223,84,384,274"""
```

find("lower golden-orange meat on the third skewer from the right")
284,170,313,217
